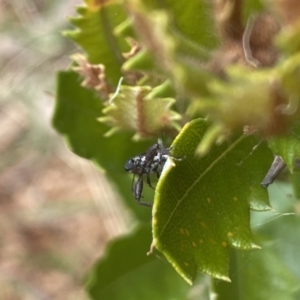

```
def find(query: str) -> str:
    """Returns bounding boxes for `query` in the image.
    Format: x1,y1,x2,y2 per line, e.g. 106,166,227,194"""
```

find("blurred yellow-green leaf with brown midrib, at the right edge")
188,58,300,143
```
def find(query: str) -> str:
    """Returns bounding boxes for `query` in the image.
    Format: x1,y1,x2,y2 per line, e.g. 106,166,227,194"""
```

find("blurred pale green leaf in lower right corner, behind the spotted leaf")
213,182,300,300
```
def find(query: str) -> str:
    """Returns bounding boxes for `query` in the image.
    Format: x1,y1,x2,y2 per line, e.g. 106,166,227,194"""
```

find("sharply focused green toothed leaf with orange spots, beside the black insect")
153,119,272,283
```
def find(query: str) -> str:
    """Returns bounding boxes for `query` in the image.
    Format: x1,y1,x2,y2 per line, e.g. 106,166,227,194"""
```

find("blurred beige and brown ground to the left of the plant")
0,0,126,300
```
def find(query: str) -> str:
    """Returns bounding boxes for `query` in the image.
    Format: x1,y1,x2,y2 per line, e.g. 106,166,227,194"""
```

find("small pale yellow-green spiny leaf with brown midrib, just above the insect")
98,86,180,138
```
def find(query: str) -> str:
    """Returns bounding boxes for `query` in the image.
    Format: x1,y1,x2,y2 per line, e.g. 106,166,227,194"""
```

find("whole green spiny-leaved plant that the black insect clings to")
53,0,300,299
